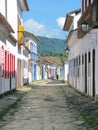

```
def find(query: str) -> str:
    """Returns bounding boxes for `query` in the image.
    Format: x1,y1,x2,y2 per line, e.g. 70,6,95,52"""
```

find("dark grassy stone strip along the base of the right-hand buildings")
61,86,98,130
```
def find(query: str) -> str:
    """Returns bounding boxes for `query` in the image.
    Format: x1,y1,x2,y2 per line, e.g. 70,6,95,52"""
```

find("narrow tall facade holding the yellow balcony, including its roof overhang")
16,0,29,88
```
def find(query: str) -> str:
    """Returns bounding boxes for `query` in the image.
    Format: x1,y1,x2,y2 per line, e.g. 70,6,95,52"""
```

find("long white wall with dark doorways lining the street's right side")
69,29,98,96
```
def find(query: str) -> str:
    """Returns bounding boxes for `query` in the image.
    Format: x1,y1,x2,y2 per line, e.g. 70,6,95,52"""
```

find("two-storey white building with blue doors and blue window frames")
24,31,39,82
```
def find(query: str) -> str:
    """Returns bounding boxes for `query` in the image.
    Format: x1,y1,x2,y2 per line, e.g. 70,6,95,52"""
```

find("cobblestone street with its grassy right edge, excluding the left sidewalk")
0,80,98,130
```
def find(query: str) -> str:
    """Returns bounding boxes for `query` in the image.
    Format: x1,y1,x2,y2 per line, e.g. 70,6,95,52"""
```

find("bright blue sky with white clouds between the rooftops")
23,0,81,39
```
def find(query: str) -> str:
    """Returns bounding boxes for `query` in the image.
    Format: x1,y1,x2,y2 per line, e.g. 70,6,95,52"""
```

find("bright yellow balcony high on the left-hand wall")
18,25,24,45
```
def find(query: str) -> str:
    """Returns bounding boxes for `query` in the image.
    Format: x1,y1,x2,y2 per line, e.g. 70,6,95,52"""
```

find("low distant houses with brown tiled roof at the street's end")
39,56,62,79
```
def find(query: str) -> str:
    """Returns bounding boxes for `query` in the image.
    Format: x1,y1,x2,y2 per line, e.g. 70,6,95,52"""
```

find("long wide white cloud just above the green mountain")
24,19,61,38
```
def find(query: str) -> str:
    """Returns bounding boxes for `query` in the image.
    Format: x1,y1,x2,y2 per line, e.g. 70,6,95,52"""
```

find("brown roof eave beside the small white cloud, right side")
63,9,81,31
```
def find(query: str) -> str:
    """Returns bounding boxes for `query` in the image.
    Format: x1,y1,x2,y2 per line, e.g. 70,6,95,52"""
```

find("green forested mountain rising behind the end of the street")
38,36,67,55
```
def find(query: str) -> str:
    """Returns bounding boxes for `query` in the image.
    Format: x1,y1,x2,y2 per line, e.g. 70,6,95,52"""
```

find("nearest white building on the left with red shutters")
0,0,17,94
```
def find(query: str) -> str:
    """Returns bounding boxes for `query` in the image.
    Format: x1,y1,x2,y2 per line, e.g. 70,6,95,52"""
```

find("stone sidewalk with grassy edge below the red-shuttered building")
0,87,31,120
